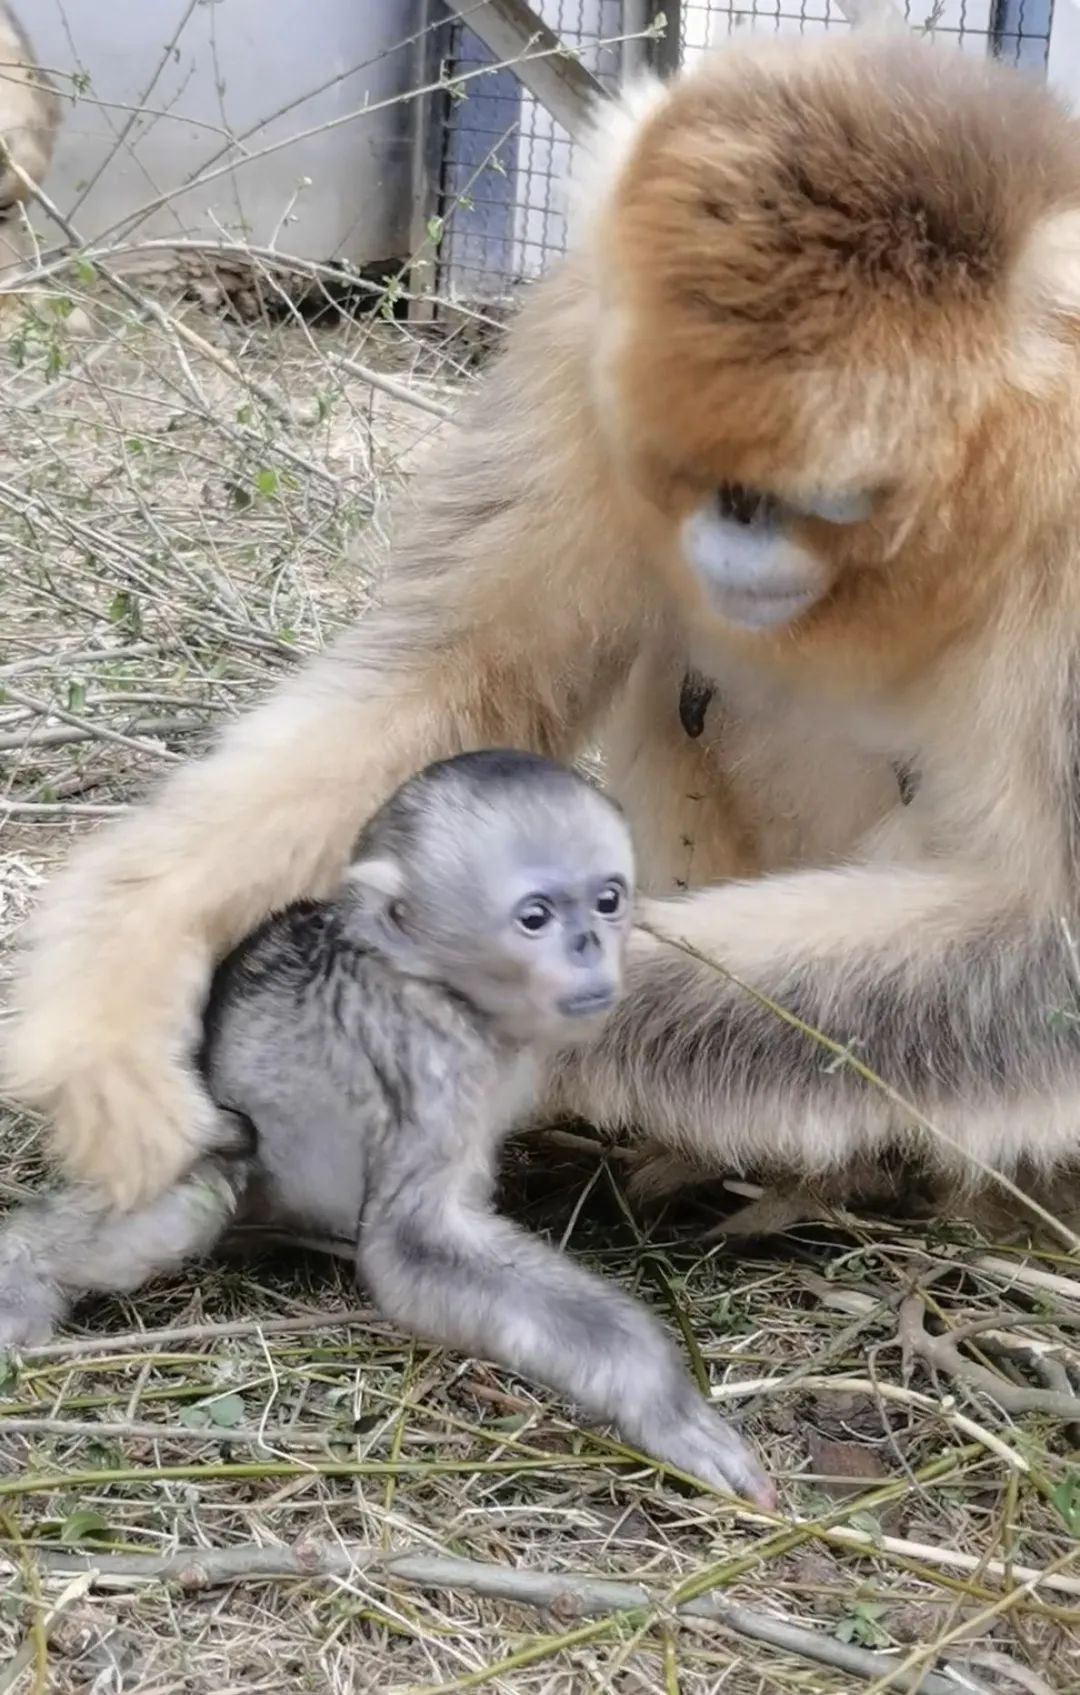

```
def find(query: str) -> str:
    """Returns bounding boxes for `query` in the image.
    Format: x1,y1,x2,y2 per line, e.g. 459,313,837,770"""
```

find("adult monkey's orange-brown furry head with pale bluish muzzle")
595,39,1080,667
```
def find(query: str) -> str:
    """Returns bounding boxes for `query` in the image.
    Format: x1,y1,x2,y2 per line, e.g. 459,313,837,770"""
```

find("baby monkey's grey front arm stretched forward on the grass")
358,1142,775,1507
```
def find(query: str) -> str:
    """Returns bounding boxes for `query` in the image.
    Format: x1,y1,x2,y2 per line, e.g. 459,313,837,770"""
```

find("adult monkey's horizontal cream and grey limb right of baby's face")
551,861,1078,1178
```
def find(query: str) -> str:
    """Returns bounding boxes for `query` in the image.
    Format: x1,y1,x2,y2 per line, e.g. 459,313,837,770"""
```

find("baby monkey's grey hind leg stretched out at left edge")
0,1158,248,1348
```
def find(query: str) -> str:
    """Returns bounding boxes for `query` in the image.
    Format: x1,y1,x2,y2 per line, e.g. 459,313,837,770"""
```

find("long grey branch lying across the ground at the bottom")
16,1544,956,1695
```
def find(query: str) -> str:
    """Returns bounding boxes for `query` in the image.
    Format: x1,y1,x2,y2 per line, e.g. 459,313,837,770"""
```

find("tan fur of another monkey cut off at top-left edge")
0,0,59,284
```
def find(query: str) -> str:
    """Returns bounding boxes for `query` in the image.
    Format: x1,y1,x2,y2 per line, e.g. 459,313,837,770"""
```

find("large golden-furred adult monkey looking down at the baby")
12,37,1080,1203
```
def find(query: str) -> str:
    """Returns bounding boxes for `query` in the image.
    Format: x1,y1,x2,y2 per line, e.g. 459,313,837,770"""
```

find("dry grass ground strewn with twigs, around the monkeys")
0,276,1080,1695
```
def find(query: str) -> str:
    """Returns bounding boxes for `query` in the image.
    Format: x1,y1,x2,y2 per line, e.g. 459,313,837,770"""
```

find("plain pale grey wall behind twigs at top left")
21,0,419,263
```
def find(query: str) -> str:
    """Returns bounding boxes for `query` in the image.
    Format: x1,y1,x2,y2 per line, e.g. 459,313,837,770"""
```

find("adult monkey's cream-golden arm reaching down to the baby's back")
5,270,648,1205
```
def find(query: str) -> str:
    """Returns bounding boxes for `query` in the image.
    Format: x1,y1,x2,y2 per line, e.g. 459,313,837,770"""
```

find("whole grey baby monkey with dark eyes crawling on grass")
0,749,775,1505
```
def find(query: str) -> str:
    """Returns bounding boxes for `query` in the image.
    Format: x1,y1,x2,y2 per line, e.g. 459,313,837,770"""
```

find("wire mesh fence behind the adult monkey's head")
428,0,1053,303
